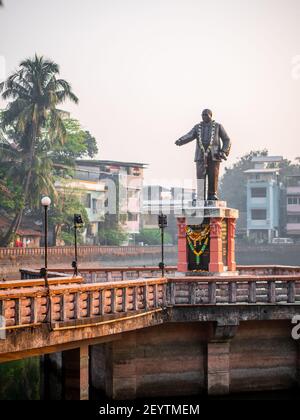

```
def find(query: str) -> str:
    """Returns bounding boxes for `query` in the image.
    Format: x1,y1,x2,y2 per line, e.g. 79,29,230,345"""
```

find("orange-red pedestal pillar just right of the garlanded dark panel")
208,218,224,273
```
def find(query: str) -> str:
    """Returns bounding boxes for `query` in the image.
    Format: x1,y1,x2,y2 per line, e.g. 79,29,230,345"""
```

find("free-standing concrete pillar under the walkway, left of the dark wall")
62,345,89,400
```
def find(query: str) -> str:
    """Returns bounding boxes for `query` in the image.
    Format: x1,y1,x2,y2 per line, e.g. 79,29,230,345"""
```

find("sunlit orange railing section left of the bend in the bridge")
0,278,167,328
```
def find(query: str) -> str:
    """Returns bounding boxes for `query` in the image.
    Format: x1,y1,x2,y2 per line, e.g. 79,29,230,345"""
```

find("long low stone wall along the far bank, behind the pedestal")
0,244,300,277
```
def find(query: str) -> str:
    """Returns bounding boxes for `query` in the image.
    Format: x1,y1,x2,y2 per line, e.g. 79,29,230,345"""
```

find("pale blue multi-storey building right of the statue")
245,156,283,242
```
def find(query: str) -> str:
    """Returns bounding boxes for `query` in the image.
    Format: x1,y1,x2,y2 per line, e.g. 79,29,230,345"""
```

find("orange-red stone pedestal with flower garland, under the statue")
177,201,238,275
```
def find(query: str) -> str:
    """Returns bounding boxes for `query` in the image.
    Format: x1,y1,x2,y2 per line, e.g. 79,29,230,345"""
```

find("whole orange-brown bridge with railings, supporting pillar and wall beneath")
0,266,300,399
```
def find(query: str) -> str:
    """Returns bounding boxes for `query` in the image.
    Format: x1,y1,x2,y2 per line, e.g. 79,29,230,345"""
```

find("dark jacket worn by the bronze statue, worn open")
179,122,231,162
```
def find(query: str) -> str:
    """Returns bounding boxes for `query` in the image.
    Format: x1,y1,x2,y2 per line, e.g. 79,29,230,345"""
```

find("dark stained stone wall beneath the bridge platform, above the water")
91,321,299,399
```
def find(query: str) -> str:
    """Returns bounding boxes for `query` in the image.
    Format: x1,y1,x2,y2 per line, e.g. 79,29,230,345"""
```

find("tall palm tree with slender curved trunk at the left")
0,55,78,246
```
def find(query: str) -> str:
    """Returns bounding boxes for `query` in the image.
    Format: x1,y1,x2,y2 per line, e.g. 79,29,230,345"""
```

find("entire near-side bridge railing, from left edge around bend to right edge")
0,274,300,328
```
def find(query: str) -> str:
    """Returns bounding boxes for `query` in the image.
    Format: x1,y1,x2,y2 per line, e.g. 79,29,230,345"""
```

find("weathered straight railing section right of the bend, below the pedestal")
167,274,300,305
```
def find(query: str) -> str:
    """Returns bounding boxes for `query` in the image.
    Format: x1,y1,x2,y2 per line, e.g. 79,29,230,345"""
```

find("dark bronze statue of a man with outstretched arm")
175,109,231,200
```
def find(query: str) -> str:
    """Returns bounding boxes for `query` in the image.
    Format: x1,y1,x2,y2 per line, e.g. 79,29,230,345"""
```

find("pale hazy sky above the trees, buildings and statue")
0,0,300,183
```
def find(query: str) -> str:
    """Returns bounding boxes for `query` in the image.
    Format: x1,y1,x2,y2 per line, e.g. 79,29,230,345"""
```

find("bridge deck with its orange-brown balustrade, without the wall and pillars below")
0,267,300,361
